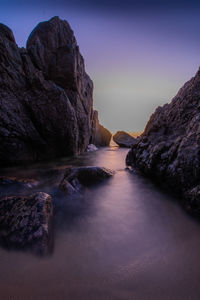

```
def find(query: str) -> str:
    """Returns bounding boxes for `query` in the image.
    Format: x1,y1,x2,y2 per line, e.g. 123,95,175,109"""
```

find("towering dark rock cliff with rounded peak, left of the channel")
0,17,111,164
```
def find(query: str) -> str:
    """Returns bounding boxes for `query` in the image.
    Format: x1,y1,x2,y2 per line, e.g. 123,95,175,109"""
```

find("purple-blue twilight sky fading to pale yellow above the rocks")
0,0,200,132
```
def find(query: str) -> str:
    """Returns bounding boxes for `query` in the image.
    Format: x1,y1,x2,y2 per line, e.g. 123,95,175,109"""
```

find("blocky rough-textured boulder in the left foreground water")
0,192,53,254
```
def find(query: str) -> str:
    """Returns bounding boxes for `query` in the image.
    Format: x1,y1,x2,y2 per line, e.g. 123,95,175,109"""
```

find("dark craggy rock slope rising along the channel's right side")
126,70,200,214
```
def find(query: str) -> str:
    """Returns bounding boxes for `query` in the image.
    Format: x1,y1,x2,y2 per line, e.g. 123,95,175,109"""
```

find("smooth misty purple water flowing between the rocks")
0,148,200,300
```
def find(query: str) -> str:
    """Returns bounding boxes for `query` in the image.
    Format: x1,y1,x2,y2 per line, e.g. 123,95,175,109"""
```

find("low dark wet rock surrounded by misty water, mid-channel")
60,166,114,196
